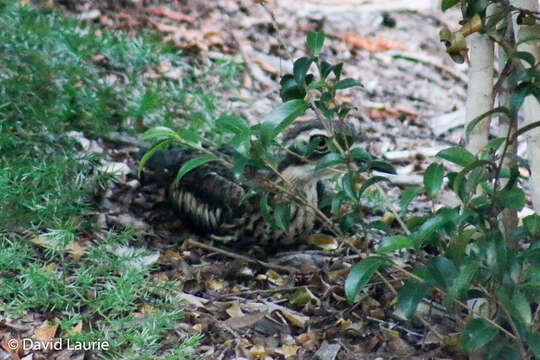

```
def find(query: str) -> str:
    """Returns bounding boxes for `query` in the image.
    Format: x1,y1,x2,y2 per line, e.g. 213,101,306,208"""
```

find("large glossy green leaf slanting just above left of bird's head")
258,99,309,145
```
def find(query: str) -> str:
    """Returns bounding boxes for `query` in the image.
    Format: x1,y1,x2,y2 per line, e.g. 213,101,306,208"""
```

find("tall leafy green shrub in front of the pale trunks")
345,0,540,359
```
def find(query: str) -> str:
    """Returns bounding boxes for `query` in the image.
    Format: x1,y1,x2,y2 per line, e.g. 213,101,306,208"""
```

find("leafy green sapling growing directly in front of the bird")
139,32,394,239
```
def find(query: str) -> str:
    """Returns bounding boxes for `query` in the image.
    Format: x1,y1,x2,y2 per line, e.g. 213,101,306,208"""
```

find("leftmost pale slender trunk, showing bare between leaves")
465,33,493,154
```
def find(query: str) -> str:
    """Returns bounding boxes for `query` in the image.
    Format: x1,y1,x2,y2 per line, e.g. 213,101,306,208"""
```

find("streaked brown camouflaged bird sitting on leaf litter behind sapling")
140,120,357,244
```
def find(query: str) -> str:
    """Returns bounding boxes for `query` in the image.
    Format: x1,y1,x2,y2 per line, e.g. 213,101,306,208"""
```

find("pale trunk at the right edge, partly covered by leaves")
510,0,540,215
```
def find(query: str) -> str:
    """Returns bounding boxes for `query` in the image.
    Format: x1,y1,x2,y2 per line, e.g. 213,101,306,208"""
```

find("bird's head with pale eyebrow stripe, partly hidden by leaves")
278,120,360,185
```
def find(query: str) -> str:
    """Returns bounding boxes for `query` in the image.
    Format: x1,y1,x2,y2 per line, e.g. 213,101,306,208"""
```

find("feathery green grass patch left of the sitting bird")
0,0,244,359
